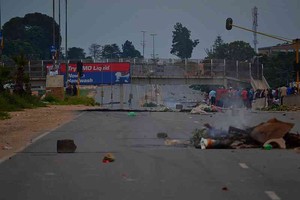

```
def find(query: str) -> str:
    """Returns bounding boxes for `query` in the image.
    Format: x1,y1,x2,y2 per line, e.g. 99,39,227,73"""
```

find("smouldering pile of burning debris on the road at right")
191,118,300,149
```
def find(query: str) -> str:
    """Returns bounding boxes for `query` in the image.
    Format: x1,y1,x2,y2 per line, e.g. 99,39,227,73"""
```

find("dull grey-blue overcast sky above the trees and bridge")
1,0,300,58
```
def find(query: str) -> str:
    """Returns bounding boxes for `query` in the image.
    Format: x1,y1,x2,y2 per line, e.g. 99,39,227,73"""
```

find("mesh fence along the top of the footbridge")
4,59,263,81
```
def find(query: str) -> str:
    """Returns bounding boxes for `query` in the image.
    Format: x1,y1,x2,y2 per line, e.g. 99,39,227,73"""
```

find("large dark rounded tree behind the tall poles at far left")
3,13,61,59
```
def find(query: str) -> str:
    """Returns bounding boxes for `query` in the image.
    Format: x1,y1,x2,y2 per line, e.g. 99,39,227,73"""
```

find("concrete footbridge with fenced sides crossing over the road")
2,59,268,89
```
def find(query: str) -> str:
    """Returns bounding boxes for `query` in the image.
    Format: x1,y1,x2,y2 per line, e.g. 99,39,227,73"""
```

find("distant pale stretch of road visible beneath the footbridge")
95,84,204,109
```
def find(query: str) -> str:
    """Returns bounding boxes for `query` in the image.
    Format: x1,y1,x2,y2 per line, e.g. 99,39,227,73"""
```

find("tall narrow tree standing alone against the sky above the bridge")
170,22,199,59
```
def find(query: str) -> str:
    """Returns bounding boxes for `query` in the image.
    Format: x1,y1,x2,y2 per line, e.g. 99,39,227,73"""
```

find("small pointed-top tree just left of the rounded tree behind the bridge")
205,35,228,59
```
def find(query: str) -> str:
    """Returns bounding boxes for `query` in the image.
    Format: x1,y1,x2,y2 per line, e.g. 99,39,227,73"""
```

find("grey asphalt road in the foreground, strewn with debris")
0,111,300,200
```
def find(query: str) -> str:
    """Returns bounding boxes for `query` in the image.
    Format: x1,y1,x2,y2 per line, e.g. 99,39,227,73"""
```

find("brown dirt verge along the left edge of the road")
0,105,94,159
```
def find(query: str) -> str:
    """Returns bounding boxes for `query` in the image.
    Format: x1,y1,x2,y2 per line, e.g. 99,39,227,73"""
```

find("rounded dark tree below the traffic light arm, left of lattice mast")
226,41,255,61
